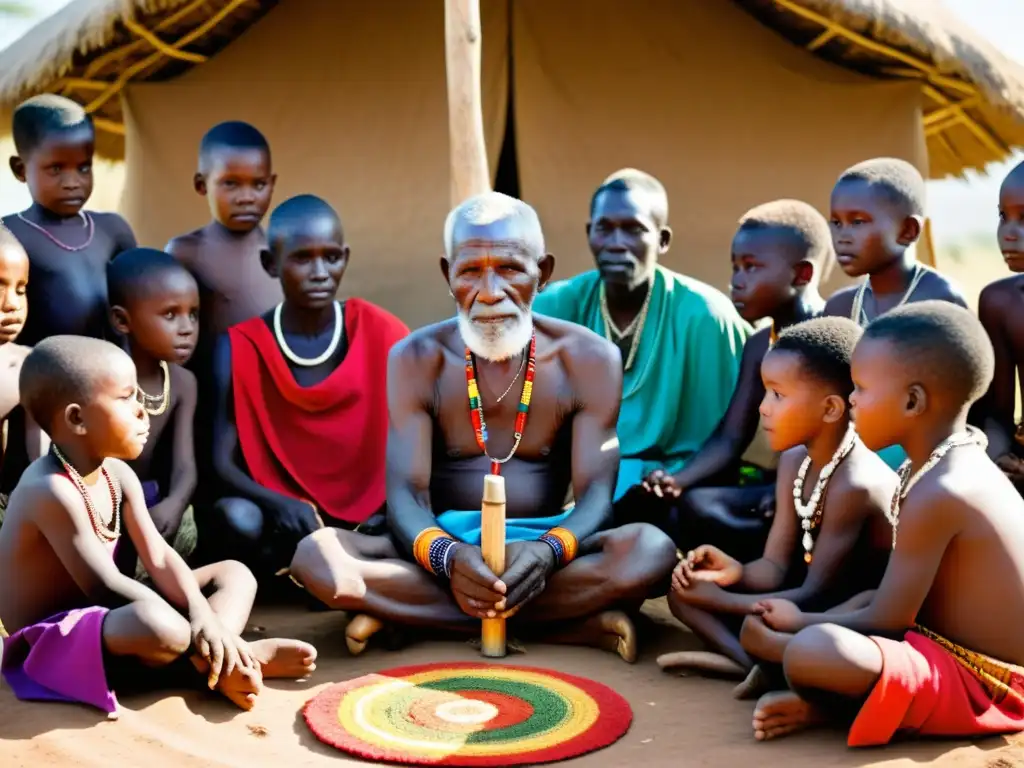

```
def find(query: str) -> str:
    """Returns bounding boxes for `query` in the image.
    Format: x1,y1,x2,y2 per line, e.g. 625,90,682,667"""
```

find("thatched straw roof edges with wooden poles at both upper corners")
0,0,1024,178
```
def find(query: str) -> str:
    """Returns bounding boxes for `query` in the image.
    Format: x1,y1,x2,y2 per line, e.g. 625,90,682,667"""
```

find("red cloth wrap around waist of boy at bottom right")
847,630,1024,746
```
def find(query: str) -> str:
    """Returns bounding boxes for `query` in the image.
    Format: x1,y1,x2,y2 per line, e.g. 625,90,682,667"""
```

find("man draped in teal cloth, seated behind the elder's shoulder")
534,169,751,520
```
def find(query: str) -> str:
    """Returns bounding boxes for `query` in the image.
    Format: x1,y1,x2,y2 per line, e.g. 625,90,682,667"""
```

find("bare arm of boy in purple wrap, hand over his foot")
115,461,259,688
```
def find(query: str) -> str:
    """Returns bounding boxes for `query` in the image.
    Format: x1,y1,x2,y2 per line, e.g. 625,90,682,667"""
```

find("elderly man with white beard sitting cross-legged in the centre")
291,193,676,662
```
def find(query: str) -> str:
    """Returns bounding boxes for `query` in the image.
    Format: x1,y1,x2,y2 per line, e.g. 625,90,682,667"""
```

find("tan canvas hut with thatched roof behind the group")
0,0,1024,325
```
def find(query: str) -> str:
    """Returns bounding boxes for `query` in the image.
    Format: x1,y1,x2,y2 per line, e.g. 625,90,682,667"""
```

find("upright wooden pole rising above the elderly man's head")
444,0,490,208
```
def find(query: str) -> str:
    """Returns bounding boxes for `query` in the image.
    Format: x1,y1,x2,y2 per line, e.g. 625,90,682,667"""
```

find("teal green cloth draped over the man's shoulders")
534,266,752,500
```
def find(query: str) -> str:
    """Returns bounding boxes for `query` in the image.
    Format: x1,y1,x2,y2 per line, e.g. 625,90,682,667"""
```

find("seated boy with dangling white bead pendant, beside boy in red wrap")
658,317,896,693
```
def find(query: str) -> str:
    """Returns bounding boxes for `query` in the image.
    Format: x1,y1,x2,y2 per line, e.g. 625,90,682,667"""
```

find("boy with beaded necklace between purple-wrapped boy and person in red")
106,248,199,575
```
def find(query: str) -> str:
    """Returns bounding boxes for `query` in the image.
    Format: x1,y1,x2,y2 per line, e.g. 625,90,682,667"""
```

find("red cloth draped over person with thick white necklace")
228,299,409,523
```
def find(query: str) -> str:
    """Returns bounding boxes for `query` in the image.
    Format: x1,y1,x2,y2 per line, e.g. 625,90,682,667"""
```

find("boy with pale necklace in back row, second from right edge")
825,158,967,469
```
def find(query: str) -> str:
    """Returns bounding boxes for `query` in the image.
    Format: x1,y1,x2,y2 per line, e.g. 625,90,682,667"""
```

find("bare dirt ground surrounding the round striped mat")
0,601,1024,768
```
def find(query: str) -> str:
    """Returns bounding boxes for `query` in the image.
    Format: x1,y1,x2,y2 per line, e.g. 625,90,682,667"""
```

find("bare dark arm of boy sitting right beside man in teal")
675,331,768,490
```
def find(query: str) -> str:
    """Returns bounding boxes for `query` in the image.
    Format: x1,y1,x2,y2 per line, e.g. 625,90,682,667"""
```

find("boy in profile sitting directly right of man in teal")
647,200,835,559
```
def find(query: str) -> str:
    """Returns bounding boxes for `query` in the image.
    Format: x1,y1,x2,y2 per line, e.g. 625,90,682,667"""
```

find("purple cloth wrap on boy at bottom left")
2,606,118,714
